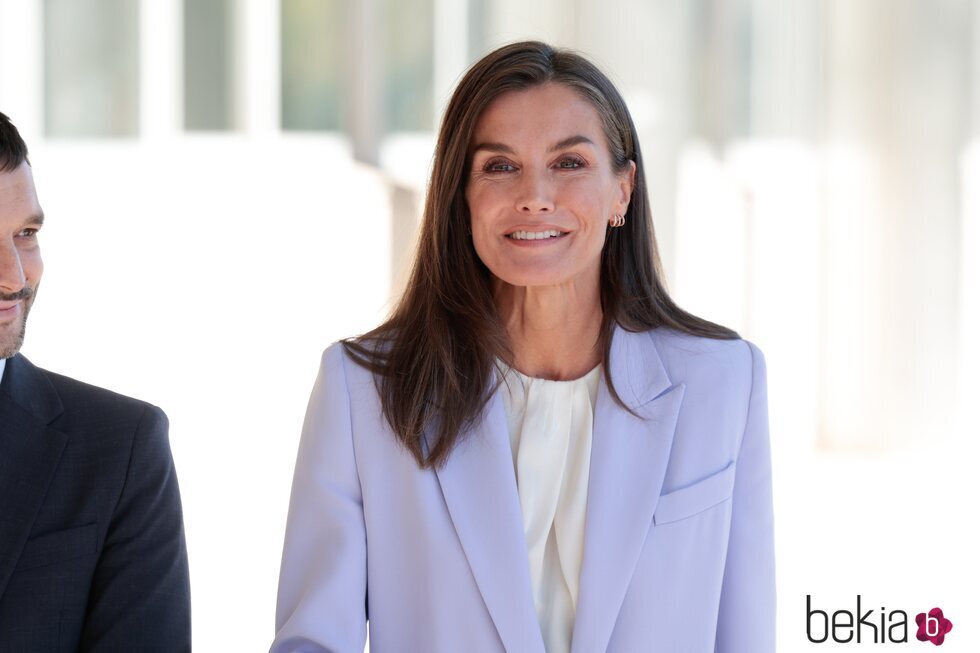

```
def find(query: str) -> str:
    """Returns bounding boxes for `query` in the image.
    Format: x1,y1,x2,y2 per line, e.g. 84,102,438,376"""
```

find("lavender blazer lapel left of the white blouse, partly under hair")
426,390,545,653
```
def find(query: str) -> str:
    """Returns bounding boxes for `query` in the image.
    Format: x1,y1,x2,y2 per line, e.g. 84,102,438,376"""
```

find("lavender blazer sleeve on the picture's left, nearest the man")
271,344,367,653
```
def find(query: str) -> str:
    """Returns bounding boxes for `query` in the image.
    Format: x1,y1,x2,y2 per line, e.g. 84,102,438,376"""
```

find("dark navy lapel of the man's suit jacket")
0,355,68,599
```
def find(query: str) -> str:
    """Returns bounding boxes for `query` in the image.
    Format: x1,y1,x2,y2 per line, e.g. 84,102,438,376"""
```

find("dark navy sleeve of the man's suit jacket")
80,406,191,653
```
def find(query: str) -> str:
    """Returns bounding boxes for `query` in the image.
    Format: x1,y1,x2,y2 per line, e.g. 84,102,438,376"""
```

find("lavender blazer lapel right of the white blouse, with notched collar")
572,327,684,653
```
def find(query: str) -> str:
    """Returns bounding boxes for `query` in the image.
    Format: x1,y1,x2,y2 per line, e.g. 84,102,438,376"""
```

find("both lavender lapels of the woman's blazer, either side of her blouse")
423,327,684,653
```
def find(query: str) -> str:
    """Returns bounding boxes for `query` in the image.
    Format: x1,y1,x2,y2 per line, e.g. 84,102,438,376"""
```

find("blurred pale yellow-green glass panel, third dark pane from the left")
281,0,347,131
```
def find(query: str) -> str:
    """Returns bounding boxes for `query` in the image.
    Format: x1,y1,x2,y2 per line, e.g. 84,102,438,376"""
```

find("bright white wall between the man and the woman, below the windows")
23,138,391,651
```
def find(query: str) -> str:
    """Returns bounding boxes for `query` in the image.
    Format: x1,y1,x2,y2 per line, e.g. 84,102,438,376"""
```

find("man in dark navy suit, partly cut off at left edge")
0,113,190,653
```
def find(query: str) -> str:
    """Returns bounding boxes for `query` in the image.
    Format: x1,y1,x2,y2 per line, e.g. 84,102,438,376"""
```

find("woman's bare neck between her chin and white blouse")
494,281,602,381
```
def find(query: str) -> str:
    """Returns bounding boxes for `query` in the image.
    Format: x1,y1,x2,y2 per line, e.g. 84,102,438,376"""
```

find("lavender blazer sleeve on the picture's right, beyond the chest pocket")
715,341,776,653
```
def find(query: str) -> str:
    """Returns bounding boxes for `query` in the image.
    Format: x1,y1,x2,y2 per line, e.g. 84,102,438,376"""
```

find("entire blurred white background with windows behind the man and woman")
0,0,980,652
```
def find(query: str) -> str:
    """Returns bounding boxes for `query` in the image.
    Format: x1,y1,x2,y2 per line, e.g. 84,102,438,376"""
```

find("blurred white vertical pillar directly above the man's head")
0,0,44,140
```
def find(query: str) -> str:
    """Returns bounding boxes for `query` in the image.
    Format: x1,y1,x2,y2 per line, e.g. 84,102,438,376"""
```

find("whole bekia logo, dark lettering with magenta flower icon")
806,594,953,646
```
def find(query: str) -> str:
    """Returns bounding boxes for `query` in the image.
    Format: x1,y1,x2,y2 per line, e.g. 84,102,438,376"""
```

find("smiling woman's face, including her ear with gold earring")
466,83,636,286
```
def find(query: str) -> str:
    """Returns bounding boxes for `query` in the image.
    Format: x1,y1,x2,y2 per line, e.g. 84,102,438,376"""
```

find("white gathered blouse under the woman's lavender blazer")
503,365,601,653
